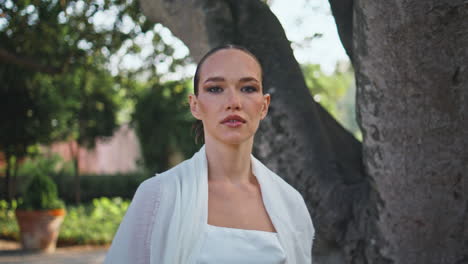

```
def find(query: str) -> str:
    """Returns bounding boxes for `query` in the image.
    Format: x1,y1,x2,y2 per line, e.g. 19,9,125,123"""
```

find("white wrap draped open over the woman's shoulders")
104,146,315,264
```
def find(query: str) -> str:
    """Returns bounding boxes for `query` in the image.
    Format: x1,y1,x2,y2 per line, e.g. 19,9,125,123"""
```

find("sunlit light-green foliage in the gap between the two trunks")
301,64,362,139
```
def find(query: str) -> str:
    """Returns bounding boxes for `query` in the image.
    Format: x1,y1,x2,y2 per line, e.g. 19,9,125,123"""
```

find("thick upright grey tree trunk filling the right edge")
330,0,468,264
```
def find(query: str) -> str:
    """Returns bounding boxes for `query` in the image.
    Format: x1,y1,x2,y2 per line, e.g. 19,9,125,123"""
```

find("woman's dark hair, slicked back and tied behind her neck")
192,44,263,143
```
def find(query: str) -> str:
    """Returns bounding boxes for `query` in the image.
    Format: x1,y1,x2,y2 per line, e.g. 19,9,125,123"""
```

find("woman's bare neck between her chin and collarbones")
205,138,254,183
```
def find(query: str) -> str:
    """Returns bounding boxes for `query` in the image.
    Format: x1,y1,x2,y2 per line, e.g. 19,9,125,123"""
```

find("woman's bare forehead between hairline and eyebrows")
200,49,261,81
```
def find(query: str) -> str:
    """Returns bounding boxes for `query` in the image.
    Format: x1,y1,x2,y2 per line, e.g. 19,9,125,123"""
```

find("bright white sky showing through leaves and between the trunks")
0,0,348,76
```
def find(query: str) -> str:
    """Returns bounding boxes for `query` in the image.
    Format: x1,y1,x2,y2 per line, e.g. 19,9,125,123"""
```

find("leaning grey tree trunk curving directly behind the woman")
140,0,369,263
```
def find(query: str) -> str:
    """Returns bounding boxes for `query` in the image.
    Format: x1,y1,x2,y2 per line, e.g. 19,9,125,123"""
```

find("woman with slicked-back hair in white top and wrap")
105,45,314,264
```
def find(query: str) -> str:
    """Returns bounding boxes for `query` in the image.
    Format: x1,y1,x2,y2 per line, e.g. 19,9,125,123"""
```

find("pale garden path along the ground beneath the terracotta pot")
0,240,107,264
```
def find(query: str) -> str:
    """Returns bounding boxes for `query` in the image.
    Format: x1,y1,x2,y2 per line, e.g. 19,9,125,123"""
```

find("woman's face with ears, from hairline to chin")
189,49,270,144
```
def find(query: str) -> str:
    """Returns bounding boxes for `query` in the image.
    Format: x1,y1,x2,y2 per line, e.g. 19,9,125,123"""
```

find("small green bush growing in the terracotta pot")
18,172,65,210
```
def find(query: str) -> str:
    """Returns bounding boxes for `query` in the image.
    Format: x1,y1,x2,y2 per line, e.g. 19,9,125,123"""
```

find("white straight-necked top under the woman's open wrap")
195,225,286,264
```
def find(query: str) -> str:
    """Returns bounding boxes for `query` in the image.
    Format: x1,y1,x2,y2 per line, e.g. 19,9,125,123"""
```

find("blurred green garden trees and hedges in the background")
0,0,361,244
